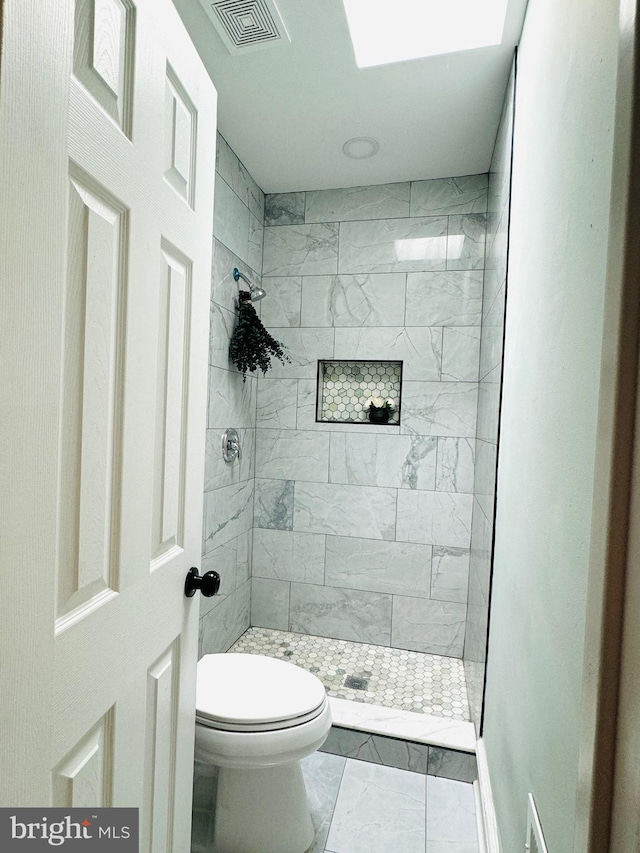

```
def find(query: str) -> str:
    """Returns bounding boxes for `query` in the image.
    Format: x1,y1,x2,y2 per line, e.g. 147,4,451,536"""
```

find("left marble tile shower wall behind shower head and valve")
200,136,264,654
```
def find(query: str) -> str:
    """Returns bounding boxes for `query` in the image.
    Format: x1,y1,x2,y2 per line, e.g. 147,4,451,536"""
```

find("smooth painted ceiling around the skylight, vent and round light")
173,0,527,193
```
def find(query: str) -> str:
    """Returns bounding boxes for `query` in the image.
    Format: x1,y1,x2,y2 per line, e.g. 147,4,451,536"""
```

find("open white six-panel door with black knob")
0,0,216,853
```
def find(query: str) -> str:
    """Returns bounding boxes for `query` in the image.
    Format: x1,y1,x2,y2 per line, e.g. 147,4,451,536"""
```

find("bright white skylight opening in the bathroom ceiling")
342,0,508,68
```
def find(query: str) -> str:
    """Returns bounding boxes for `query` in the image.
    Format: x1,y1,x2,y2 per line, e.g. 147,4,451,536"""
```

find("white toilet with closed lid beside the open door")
195,654,331,853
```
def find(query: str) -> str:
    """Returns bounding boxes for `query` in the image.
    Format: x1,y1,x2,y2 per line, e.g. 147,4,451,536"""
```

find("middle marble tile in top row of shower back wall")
305,182,409,222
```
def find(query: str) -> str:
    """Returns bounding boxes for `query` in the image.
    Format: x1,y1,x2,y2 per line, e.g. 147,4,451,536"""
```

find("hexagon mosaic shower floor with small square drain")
229,628,470,722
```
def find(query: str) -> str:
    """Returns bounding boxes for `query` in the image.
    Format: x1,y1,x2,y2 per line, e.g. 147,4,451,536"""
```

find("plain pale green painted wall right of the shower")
484,0,617,853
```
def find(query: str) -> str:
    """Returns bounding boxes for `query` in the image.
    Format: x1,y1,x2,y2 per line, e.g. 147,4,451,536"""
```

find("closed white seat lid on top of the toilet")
196,653,326,724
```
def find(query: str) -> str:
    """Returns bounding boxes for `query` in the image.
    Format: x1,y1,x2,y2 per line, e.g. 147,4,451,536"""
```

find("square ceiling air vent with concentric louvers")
200,0,291,54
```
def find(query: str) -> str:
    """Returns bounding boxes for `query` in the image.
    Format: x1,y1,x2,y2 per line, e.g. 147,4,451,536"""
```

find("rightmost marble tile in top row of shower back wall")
411,174,488,216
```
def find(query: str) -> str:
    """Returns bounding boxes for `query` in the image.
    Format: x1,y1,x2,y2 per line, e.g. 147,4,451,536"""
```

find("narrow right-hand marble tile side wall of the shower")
463,74,514,724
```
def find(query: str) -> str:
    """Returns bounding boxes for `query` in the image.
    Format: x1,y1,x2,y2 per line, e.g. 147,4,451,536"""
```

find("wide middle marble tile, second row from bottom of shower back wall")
324,536,431,598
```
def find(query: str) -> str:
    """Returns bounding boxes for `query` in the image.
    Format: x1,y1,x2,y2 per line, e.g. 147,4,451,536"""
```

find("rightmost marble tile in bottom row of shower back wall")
391,595,467,656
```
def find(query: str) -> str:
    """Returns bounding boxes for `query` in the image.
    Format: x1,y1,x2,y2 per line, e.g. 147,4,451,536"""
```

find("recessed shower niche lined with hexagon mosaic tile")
316,361,402,425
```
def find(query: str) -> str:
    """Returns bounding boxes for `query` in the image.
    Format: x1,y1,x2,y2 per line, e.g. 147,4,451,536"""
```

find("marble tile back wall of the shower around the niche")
251,175,487,657
